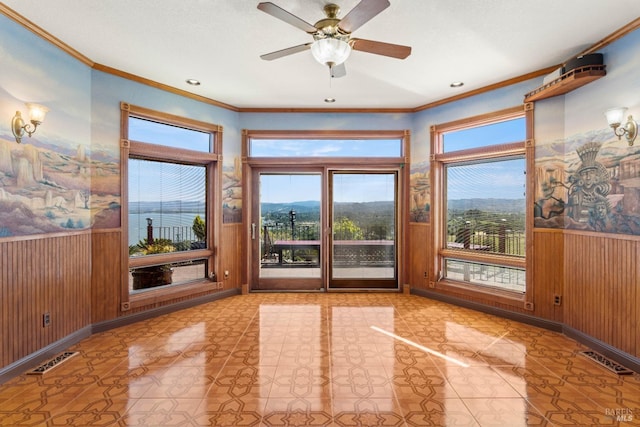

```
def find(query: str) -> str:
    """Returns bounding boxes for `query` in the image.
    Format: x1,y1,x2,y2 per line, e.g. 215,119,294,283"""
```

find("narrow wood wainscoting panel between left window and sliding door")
216,224,245,289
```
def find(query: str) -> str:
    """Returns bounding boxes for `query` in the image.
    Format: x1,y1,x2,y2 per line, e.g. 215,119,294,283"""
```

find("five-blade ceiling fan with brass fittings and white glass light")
258,0,411,77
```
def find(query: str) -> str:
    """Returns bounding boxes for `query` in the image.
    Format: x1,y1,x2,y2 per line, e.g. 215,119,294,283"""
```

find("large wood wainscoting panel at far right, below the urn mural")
564,231,640,357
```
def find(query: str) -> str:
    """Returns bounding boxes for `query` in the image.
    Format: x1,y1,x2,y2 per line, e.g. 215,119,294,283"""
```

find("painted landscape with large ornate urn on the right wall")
534,128,640,235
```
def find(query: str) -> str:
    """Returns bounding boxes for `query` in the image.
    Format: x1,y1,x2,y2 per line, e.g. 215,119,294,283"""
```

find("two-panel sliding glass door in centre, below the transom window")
251,169,398,291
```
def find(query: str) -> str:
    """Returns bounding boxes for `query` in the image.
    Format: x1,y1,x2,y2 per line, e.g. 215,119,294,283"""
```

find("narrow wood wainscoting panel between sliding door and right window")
409,222,431,289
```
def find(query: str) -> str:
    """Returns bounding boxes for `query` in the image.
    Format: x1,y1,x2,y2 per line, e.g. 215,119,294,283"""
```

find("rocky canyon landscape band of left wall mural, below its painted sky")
0,137,119,237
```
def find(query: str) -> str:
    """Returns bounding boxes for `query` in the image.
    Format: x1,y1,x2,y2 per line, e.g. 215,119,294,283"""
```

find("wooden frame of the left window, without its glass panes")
120,102,222,311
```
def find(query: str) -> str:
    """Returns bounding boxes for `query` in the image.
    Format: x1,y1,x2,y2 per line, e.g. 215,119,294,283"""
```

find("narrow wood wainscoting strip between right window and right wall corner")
529,228,564,322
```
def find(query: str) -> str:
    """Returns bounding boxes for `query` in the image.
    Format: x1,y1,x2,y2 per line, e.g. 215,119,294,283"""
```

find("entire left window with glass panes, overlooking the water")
122,104,221,304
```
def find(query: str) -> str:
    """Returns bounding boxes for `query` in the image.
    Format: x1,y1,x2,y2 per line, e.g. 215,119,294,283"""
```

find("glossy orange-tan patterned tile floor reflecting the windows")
0,293,640,427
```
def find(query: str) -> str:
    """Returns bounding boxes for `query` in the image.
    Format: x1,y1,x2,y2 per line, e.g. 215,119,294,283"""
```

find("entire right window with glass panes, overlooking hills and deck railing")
432,107,531,300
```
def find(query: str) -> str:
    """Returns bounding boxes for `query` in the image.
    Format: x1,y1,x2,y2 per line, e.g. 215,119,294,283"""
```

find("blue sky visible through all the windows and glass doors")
129,118,526,203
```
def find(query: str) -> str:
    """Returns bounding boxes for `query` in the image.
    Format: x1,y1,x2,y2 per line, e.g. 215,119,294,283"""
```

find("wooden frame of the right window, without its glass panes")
429,103,535,310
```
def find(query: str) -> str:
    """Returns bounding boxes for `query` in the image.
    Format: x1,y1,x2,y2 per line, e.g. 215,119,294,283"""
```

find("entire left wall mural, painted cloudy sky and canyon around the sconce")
0,16,120,237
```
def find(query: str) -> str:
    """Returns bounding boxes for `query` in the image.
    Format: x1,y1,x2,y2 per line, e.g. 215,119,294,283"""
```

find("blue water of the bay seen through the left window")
129,210,205,245
